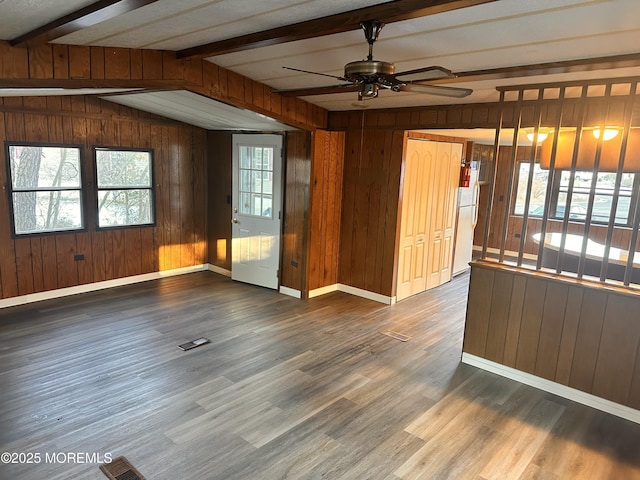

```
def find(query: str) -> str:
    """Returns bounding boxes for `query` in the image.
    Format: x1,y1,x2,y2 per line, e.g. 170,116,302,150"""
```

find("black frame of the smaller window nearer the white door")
91,145,157,231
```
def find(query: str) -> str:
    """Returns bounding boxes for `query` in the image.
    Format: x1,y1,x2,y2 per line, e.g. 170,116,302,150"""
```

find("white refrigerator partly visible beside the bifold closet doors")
452,167,480,275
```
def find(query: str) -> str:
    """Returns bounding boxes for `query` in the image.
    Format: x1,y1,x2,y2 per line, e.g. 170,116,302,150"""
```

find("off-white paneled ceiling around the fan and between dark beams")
0,0,640,127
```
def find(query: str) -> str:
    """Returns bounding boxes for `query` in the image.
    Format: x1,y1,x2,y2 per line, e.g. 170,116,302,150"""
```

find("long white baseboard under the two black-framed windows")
0,264,209,309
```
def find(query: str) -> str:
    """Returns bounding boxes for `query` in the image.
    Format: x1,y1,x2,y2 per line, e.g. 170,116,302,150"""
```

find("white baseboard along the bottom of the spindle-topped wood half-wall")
462,353,640,424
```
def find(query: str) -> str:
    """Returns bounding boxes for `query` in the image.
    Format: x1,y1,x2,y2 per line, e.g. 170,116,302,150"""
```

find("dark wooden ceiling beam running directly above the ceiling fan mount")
177,0,496,58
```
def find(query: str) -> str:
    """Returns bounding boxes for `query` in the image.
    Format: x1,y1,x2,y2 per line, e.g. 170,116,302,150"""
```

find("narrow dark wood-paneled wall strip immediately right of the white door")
280,132,311,296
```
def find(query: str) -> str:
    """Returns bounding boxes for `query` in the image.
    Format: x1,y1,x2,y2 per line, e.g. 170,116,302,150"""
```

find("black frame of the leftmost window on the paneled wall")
4,140,88,239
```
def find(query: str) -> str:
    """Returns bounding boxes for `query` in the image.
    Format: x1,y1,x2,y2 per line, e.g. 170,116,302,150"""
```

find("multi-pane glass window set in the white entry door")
239,145,273,218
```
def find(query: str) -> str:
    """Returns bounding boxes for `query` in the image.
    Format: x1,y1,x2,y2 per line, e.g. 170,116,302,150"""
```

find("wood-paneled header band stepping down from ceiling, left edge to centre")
0,41,328,130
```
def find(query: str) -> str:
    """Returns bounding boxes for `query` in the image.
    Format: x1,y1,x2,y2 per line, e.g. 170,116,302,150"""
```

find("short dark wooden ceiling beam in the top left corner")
9,0,157,47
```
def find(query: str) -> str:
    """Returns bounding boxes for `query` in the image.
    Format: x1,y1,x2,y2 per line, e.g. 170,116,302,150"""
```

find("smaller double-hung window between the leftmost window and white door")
94,148,154,228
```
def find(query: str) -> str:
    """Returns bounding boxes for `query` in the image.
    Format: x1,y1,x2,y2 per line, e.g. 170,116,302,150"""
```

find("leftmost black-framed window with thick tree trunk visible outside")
6,142,84,235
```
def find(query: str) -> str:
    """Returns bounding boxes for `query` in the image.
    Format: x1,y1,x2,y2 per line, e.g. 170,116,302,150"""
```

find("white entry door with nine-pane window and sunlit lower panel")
231,135,282,289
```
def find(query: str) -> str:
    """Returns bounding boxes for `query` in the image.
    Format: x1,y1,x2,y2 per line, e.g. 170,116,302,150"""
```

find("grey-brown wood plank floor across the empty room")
0,272,640,480
